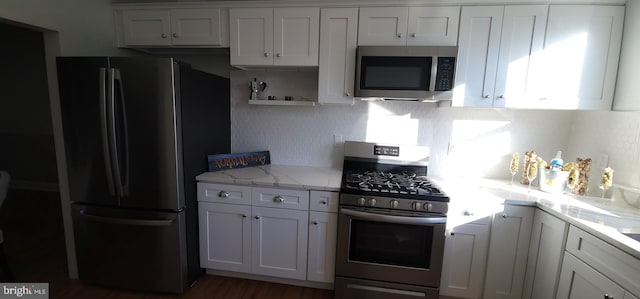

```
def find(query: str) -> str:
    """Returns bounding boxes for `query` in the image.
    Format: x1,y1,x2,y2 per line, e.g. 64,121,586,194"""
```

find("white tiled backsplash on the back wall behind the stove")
231,71,573,178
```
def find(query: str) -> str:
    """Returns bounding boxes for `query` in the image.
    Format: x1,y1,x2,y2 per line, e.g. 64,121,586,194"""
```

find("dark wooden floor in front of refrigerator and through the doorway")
0,189,333,299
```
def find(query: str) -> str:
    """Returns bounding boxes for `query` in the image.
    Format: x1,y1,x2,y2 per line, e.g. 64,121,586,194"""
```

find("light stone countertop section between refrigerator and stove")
196,164,342,191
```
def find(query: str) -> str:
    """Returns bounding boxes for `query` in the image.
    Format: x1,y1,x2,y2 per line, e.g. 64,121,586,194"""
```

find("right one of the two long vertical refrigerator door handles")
113,68,130,197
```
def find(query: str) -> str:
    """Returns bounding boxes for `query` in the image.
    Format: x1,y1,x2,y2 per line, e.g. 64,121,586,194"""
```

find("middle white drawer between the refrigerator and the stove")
252,188,309,210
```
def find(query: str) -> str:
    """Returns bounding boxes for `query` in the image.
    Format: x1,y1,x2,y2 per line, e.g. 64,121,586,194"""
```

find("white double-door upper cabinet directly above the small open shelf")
229,7,320,66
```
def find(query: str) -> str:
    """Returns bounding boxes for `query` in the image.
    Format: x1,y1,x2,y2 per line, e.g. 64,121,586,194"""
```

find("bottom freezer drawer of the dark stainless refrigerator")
72,204,188,293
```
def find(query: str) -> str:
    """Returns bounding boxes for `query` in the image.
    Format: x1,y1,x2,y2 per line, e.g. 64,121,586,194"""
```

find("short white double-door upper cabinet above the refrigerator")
116,8,228,47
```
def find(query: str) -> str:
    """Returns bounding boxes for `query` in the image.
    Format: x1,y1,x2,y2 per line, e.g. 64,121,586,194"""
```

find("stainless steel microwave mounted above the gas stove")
355,46,458,101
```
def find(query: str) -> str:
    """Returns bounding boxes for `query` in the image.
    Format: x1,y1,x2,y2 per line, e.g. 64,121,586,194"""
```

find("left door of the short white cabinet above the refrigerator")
122,10,171,46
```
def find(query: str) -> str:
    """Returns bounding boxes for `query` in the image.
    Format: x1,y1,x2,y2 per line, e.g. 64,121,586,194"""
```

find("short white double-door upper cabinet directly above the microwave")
358,6,460,46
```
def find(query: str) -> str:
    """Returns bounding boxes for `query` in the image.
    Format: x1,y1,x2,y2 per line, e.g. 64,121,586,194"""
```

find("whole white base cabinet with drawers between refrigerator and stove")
198,183,339,284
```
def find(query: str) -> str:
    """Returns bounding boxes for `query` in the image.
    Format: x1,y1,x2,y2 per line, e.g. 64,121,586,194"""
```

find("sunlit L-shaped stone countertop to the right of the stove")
436,179,640,259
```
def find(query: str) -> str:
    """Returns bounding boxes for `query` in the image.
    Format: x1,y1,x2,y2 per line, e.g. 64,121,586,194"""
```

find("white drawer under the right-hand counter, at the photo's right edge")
566,226,640,294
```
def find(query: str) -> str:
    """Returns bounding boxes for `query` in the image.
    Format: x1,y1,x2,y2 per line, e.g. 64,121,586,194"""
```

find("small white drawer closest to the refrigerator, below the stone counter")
198,183,251,205
